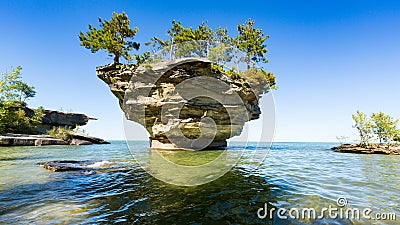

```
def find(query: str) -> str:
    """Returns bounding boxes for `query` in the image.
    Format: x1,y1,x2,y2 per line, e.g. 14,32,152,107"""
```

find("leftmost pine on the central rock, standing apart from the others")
79,12,140,63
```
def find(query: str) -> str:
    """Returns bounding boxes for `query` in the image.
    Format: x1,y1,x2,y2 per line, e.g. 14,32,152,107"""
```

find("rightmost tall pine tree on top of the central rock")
233,19,269,69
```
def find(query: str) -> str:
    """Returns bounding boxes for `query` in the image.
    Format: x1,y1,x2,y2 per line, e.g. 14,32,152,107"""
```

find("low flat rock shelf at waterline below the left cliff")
0,134,110,146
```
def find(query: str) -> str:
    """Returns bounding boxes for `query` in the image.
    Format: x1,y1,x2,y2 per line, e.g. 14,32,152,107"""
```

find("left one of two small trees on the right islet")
352,110,373,147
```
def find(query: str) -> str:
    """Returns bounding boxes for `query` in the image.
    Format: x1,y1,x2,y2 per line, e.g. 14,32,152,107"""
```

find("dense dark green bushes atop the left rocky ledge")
0,101,43,134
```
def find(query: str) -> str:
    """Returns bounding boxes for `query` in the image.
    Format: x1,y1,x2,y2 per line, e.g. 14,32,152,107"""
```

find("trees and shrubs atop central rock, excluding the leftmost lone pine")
143,20,277,93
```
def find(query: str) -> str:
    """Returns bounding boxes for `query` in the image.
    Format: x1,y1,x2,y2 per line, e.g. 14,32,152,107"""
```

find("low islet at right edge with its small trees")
332,111,400,155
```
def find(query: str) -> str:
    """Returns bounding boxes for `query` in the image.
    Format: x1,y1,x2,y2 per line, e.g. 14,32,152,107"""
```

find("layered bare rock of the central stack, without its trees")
96,58,261,150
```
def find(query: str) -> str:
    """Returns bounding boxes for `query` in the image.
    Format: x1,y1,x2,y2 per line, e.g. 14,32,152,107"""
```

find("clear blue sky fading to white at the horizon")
0,0,400,141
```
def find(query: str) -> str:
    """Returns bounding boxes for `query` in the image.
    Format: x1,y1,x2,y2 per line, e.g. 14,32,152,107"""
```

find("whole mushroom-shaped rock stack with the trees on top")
79,13,276,150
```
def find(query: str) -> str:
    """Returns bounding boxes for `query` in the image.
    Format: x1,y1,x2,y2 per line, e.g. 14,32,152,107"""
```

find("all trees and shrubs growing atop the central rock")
79,13,277,93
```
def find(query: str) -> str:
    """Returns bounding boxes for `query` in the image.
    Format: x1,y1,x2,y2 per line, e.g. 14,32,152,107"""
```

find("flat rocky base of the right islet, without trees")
331,144,400,155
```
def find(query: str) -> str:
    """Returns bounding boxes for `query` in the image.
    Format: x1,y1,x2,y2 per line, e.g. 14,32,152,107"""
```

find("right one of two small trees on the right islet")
371,112,399,144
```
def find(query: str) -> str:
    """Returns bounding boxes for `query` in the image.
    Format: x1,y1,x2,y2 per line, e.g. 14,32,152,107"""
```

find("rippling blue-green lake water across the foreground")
0,141,400,224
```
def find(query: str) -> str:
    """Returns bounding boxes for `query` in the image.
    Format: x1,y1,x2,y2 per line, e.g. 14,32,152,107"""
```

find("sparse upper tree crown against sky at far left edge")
0,66,36,101
